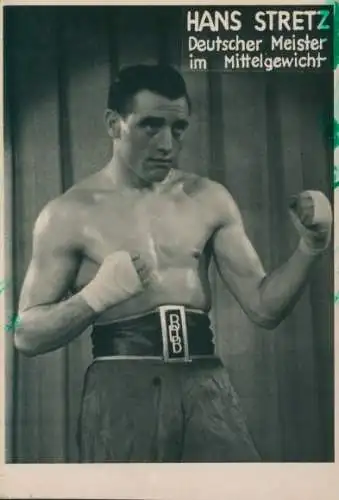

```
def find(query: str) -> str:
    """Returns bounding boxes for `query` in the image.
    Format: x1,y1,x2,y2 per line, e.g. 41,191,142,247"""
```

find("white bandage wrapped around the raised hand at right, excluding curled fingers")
290,191,332,255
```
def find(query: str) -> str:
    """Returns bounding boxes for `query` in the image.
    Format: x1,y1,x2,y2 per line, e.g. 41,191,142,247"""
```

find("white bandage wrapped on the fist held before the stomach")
79,251,142,313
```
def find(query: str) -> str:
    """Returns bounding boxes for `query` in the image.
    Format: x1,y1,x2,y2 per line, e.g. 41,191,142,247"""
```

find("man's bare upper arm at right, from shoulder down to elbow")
213,186,265,313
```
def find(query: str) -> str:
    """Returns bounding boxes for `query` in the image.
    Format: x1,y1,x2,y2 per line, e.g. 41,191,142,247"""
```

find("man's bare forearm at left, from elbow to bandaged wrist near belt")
14,294,97,356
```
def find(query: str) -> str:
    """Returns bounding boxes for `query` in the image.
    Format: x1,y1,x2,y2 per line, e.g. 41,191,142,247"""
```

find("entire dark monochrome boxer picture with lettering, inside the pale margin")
0,4,334,464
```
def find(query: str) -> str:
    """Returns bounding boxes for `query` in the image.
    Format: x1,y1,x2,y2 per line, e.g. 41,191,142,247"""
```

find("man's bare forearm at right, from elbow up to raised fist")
253,245,316,328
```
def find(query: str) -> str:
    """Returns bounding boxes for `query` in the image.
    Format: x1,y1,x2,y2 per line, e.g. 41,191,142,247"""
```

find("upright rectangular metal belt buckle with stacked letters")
159,305,192,363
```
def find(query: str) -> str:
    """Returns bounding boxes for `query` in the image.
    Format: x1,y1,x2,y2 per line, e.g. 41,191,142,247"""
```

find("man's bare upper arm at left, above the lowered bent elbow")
19,202,79,311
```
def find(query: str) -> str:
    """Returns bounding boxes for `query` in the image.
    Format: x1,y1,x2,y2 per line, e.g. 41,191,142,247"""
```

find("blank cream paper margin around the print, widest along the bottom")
0,0,339,500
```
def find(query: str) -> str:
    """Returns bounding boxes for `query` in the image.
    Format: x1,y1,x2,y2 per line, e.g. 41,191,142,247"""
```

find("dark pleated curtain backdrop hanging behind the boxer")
5,7,333,462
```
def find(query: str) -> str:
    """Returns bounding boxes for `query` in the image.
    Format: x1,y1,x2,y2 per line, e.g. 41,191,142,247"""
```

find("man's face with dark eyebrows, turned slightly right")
118,90,189,183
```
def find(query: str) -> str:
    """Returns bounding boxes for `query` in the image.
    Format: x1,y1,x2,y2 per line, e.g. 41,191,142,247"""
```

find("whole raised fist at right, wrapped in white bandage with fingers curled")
290,191,332,255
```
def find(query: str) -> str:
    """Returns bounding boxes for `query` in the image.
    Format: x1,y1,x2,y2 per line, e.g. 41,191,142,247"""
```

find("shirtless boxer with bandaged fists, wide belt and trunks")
15,66,332,462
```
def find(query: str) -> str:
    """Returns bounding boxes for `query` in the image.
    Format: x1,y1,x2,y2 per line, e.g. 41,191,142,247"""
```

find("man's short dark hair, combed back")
107,64,191,116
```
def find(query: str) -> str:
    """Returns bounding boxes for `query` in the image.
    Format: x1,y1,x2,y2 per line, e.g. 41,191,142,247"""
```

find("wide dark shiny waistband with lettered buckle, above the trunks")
91,305,215,362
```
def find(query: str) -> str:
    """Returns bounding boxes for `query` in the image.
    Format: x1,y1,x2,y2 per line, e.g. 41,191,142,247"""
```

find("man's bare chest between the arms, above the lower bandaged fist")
82,188,213,268
